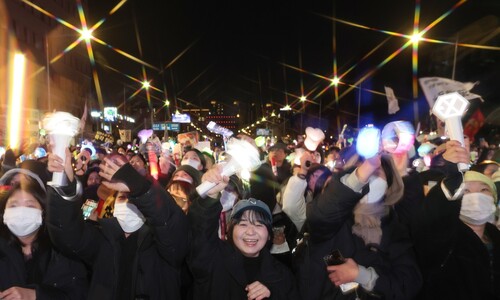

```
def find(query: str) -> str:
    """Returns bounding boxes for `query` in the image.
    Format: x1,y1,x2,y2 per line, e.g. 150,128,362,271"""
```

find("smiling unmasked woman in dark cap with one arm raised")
188,165,300,300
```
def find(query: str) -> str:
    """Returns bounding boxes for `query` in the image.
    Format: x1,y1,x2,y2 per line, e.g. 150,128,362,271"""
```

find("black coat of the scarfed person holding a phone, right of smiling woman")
298,171,422,300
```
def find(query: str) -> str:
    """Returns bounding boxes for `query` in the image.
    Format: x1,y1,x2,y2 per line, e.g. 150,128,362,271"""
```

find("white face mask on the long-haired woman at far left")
3,206,42,237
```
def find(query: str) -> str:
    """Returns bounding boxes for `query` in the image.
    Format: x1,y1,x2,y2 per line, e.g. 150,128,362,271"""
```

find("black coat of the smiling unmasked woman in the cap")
188,198,299,300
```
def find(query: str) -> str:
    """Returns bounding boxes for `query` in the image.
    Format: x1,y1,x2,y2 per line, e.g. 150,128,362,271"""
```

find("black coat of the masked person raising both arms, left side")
47,175,188,300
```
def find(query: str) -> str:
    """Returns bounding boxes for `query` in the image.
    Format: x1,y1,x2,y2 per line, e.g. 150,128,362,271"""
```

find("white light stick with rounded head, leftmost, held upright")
43,111,80,186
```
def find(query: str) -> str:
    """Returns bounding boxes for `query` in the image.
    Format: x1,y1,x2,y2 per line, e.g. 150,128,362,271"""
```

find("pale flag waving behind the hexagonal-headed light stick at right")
418,77,484,107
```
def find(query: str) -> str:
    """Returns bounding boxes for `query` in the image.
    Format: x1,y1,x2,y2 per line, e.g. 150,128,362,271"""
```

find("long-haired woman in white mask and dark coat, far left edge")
0,179,88,299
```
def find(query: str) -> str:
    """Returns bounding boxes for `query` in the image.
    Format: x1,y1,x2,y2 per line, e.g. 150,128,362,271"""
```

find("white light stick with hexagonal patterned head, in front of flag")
432,92,469,172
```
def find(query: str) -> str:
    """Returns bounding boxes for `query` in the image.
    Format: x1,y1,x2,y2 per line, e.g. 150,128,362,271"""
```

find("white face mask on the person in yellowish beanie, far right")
460,193,496,225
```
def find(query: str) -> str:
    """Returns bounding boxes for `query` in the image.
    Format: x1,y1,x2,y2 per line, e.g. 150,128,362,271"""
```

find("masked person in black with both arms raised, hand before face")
47,152,188,300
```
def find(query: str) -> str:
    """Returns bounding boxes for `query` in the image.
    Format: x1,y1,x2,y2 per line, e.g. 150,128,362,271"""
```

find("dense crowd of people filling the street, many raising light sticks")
0,122,500,300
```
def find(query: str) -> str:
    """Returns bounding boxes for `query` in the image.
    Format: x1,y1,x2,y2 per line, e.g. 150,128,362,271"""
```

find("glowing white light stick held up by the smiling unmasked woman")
196,138,262,197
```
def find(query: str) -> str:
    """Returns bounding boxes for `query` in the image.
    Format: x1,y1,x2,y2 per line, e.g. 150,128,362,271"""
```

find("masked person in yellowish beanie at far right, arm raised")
413,141,500,299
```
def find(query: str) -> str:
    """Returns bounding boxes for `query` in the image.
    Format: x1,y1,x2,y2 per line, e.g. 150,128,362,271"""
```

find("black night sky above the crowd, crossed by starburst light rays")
86,0,500,132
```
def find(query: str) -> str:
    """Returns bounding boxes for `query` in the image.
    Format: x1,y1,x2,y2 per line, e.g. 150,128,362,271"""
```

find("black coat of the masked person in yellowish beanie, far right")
413,166,500,300
